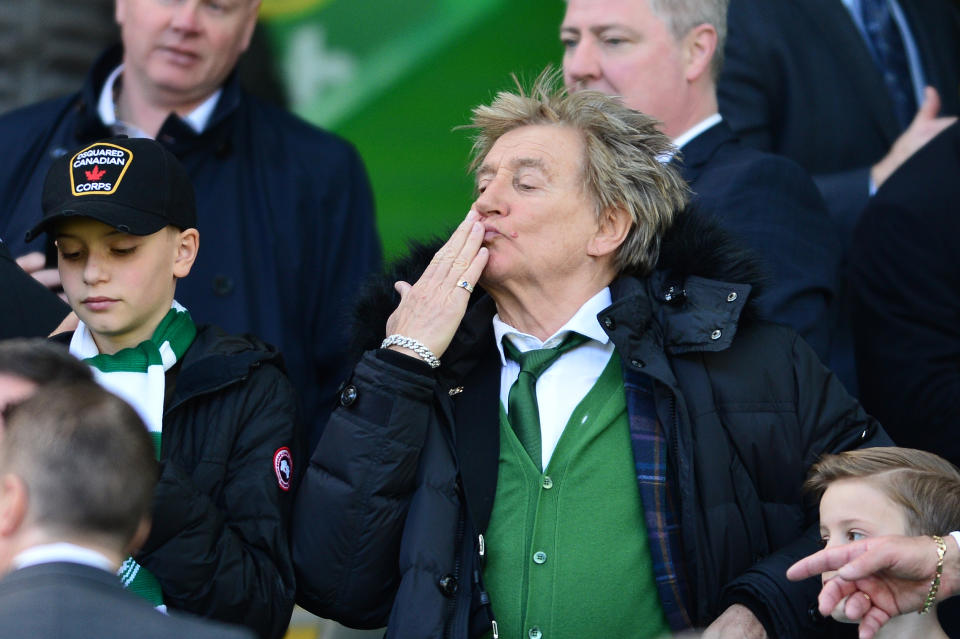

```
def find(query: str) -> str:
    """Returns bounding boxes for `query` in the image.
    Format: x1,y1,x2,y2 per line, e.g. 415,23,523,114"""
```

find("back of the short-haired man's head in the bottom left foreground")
0,381,157,573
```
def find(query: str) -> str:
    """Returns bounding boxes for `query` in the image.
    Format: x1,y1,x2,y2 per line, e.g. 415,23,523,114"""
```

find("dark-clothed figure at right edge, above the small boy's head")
851,123,960,465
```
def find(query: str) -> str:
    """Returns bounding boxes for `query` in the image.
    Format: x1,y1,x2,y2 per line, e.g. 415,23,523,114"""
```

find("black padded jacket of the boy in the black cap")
137,327,299,638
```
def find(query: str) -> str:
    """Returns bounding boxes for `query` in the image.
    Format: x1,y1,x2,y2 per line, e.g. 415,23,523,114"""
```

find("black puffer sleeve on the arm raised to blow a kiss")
292,350,435,628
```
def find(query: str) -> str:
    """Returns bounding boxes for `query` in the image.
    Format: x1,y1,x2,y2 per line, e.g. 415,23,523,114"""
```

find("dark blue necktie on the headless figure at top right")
860,0,917,128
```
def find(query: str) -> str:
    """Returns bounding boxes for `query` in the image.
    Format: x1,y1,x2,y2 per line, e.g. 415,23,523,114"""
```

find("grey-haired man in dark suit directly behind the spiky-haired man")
561,0,840,358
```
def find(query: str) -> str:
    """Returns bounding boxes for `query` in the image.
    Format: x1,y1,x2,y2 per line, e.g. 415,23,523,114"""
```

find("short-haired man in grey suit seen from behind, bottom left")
0,370,252,639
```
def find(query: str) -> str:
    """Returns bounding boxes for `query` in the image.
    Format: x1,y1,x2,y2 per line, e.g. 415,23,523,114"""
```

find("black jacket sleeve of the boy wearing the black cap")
136,365,298,639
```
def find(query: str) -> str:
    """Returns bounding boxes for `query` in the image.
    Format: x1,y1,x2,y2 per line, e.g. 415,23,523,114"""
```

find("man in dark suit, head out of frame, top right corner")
719,0,960,240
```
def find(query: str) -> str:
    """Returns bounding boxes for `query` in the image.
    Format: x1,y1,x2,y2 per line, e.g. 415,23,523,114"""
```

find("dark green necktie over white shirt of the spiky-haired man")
503,332,590,471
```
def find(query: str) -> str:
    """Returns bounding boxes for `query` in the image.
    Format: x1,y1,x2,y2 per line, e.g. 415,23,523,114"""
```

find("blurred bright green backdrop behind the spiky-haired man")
261,0,564,257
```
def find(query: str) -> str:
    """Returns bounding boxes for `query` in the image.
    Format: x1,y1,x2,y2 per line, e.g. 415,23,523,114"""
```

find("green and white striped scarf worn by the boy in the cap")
70,301,197,610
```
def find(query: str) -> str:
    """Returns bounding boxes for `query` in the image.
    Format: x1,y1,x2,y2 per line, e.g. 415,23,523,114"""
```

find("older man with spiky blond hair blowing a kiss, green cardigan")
293,75,889,639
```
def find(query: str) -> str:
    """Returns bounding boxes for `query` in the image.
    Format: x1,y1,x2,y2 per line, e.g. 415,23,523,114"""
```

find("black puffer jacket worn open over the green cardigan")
293,216,890,639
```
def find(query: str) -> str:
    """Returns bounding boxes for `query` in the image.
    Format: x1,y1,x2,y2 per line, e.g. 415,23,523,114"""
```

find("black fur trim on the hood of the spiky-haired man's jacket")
351,206,766,359
